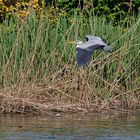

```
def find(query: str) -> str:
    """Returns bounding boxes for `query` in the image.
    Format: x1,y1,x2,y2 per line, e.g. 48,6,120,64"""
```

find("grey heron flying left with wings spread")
70,35,112,67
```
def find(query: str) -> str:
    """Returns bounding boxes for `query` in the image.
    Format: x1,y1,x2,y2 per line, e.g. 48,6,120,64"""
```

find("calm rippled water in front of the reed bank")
0,114,140,140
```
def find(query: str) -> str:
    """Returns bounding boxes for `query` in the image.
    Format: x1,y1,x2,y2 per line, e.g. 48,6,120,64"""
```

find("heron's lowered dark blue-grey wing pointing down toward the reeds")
76,42,94,67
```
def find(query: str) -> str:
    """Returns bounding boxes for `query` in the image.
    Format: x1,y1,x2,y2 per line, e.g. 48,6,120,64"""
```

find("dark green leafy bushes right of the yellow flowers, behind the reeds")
47,0,140,25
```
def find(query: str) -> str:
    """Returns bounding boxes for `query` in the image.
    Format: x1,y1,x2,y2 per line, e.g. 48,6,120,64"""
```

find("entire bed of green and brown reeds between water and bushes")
0,11,140,113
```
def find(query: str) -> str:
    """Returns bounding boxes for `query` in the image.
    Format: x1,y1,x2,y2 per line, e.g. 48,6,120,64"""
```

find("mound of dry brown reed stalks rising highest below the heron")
0,58,139,113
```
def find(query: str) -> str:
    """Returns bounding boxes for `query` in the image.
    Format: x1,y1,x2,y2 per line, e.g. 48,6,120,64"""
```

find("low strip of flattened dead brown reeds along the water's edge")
0,80,139,114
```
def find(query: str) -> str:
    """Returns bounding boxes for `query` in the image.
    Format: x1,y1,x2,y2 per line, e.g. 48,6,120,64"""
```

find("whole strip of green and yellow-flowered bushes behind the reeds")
0,0,140,25
